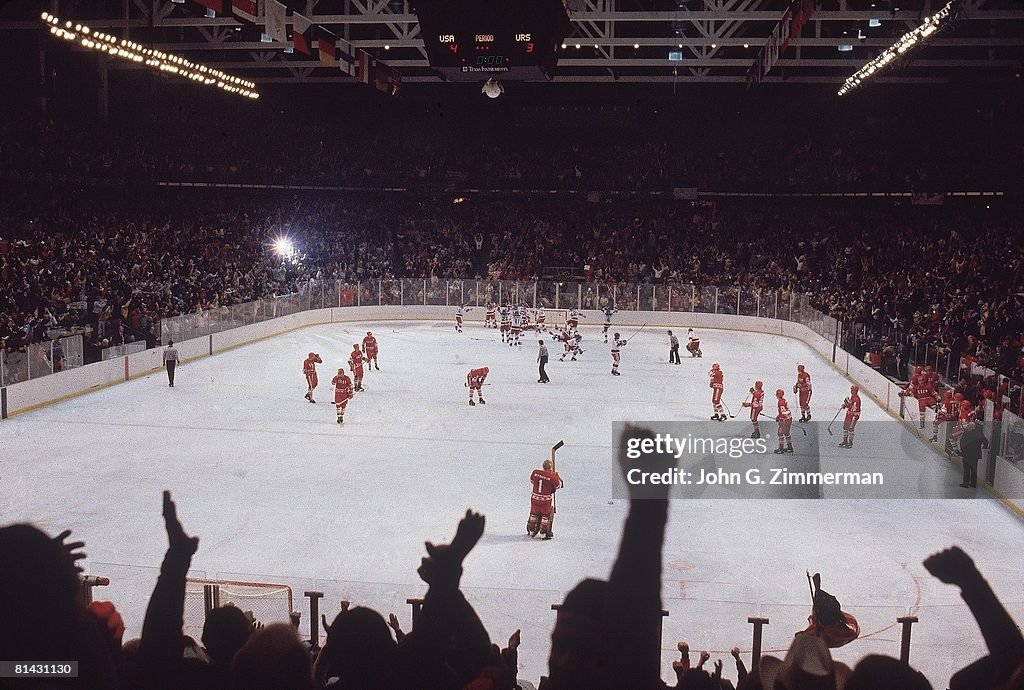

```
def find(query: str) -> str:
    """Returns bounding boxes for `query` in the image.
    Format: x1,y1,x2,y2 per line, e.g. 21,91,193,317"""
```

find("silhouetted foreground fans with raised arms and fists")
0,444,1024,690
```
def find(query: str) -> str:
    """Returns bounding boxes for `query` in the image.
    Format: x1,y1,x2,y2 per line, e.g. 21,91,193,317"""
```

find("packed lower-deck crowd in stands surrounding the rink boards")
0,187,1024,409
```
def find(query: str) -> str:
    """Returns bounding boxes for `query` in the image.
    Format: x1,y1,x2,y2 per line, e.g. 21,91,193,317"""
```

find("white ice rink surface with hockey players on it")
0,314,1024,688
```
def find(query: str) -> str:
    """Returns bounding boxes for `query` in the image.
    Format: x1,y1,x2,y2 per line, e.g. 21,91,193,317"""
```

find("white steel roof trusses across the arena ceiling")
0,0,1024,86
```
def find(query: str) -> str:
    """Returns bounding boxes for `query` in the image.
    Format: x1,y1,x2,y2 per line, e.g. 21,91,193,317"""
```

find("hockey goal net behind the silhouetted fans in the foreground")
184,577,294,640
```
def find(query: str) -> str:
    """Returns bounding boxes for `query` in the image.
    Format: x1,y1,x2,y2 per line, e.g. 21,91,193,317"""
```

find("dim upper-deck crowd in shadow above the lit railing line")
0,99,1024,192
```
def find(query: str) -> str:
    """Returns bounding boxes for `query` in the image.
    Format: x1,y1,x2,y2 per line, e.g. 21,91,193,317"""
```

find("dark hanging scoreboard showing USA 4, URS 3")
415,0,569,81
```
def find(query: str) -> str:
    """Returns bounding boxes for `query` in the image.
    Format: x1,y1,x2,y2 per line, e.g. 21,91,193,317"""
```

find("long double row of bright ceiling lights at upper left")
42,12,259,99
